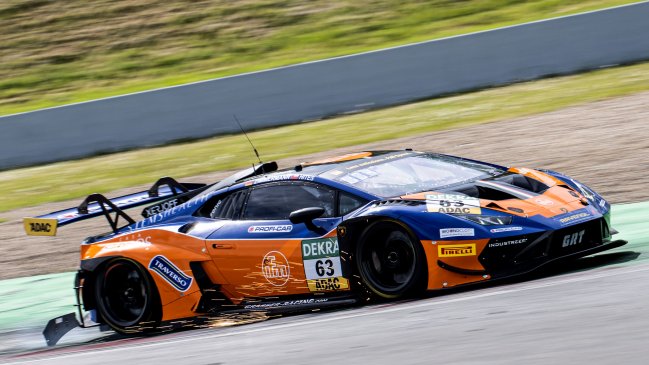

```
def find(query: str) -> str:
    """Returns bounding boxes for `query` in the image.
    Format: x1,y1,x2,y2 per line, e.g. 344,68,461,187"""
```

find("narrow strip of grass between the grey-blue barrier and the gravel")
0,63,649,211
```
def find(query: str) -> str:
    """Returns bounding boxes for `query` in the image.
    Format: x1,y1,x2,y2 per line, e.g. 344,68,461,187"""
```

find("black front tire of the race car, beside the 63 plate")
356,221,428,299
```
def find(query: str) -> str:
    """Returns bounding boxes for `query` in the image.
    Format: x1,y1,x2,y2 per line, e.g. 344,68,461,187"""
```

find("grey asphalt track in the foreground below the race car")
0,203,649,364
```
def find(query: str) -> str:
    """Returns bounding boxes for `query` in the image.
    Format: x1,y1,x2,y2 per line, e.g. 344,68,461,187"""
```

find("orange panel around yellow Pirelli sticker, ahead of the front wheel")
421,239,489,290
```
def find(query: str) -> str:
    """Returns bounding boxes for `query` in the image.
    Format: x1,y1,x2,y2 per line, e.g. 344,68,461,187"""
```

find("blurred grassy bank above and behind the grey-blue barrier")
0,0,634,115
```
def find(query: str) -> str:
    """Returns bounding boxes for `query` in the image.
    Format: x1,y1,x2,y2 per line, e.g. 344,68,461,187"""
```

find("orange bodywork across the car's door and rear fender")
81,229,349,321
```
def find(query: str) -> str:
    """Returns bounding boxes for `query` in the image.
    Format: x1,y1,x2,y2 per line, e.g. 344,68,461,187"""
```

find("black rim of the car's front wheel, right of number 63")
359,231,417,295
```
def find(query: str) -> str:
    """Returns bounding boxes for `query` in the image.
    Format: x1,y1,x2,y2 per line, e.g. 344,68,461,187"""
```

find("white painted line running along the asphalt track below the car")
9,265,649,364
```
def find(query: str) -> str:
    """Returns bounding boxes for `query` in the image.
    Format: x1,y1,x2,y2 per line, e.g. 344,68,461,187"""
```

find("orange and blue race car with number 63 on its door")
24,150,626,343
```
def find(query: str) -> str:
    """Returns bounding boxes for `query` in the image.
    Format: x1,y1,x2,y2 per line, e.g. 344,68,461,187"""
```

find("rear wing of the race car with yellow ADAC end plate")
23,177,207,236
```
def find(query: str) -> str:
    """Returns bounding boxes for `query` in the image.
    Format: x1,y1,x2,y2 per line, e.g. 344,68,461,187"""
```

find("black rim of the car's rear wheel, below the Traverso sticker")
100,262,149,328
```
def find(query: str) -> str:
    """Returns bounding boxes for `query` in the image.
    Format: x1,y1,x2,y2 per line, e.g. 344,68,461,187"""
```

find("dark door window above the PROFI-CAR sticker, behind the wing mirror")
243,183,336,220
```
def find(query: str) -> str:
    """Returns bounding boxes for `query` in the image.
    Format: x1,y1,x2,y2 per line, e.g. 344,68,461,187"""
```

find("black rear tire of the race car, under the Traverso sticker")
95,258,160,333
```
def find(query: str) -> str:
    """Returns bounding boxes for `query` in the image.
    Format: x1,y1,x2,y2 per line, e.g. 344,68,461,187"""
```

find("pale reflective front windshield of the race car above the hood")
326,154,504,197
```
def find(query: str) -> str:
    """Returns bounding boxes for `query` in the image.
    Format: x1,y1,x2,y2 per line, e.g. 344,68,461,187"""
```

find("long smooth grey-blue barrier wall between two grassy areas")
0,2,649,169
